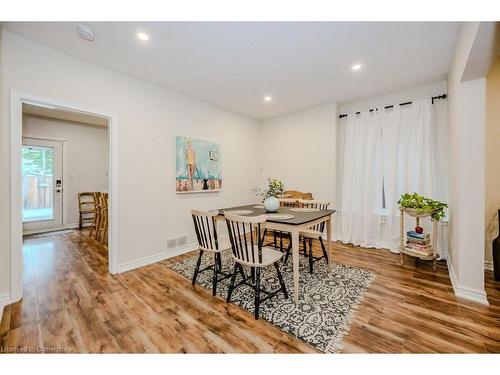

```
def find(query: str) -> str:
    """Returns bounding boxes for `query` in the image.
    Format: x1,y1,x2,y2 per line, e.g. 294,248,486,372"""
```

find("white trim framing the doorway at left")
10,90,118,303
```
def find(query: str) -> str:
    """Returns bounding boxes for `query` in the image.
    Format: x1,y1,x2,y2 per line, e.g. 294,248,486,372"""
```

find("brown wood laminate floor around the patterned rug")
0,231,500,353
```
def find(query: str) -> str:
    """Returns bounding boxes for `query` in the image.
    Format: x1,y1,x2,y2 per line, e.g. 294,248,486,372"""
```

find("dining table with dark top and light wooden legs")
216,204,335,303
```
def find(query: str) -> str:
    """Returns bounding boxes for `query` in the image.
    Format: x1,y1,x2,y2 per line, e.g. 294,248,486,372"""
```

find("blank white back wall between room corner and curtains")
261,103,336,206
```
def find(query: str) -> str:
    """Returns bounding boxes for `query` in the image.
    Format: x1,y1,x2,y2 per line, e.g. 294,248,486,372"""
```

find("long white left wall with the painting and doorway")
0,31,260,300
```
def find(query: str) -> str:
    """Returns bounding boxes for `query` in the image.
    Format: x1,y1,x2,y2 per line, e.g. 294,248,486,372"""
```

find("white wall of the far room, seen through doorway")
23,115,109,227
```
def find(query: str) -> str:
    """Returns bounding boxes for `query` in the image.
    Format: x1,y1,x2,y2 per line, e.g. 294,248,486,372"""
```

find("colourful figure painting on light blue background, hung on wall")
175,136,222,193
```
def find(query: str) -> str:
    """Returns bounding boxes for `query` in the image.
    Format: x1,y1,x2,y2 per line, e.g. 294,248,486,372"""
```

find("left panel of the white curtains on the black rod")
341,111,382,247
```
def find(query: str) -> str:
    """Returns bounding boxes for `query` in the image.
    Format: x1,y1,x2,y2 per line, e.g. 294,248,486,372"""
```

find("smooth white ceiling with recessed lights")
3,22,459,119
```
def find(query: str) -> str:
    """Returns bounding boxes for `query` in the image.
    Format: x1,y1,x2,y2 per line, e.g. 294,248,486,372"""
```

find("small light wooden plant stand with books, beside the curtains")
399,207,438,272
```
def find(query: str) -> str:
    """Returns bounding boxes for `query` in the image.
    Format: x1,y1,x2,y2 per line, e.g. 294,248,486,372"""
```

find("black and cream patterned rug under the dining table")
169,252,375,353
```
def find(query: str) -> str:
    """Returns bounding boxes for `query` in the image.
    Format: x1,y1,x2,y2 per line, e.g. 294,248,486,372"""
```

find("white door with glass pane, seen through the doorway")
22,138,63,233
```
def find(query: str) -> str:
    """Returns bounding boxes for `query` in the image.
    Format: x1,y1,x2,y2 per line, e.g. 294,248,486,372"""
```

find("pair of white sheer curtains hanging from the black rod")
339,99,448,258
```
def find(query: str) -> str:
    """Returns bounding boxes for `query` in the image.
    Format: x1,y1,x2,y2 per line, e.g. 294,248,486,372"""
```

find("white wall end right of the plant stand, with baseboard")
448,22,487,303
